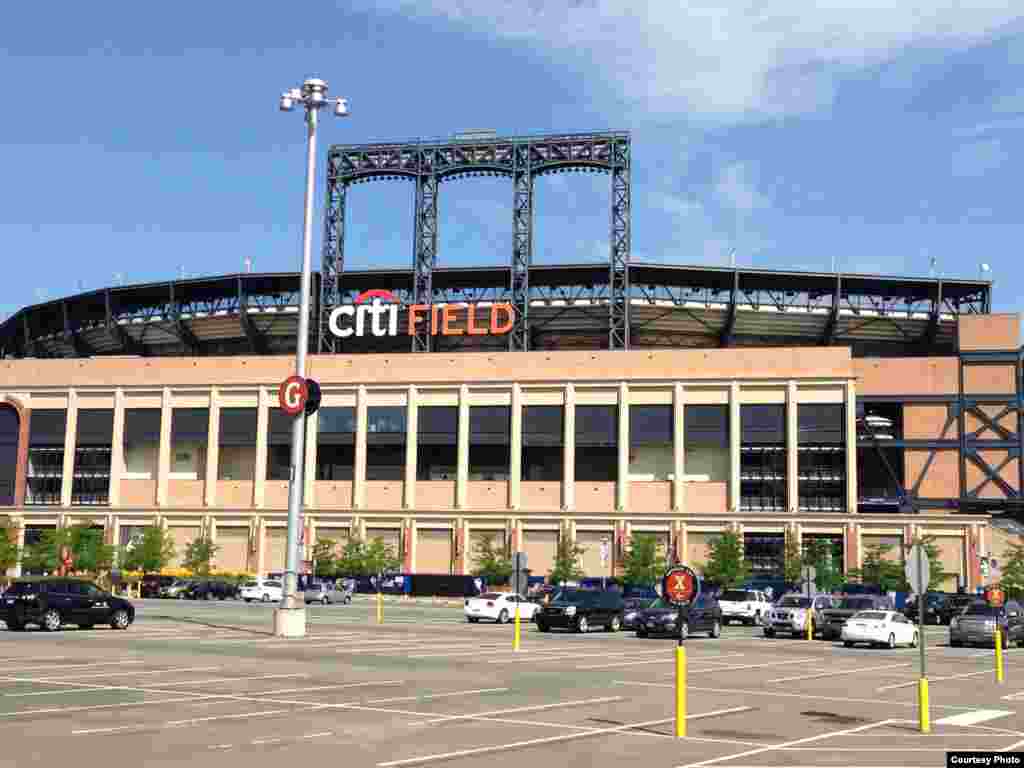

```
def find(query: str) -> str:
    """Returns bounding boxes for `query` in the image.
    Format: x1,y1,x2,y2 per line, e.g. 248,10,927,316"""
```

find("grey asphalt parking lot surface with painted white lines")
0,598,1024,768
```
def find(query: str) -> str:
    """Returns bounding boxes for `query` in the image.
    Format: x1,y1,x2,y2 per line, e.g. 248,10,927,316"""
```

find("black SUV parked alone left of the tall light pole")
0,578,135,632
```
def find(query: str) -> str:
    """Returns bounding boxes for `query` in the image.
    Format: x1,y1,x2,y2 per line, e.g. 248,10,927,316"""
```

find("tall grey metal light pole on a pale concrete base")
273,79,348,637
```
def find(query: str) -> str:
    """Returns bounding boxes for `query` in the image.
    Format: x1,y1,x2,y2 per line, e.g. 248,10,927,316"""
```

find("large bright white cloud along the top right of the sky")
374,0,1021,121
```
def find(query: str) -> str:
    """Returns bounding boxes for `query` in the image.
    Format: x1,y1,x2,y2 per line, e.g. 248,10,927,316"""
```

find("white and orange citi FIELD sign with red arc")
328,289,515,339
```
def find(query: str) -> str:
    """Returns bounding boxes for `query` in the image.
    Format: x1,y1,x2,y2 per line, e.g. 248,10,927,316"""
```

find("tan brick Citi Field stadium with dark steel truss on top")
0,133,1024,591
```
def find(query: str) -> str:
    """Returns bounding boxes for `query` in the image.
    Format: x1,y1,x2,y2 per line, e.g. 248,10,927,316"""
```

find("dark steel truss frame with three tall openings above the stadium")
317,132,631,352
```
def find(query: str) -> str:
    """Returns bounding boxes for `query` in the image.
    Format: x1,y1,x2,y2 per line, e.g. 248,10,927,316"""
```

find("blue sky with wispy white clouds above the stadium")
0,0,1024,317
